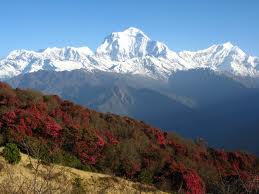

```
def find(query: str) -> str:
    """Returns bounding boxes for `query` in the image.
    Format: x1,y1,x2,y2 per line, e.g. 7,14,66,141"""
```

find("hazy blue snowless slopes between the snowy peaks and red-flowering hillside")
8,70,259,155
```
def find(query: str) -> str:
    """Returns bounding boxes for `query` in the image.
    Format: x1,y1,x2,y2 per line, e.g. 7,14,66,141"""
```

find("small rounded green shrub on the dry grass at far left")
3,143,21,164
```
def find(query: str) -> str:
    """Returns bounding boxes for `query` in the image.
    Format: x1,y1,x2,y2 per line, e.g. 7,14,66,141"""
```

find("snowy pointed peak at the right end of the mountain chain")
179,42,259,77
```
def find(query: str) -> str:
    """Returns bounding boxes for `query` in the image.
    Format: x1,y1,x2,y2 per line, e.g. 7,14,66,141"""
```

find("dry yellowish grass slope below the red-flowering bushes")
0,149,167,194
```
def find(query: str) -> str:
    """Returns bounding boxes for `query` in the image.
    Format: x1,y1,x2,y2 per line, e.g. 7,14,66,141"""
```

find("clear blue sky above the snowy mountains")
0,0,259,58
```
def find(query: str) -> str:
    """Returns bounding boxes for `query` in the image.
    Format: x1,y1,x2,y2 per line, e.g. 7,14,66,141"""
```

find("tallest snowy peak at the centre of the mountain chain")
96,27,177,61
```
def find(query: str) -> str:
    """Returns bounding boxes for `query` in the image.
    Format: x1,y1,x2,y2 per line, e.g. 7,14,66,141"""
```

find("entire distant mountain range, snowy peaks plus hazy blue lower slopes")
0,27,259,154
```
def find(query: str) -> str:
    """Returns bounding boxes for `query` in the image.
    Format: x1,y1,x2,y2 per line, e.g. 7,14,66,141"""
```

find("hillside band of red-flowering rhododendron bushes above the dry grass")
0,82,259,194
